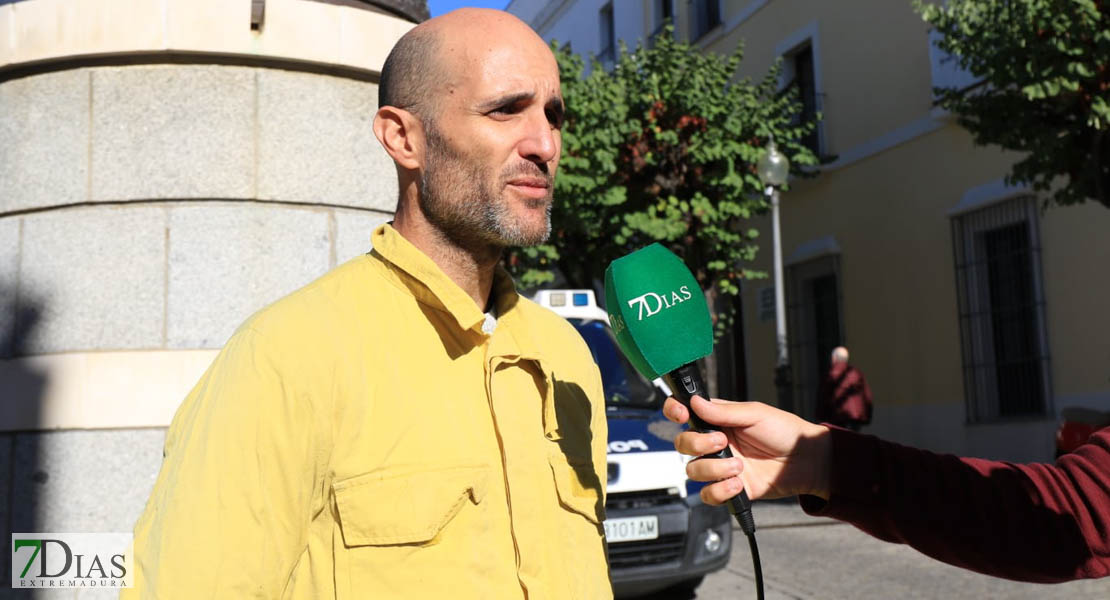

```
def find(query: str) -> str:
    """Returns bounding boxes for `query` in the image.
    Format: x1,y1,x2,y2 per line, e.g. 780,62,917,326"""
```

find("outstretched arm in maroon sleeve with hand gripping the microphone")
664,397,1110,583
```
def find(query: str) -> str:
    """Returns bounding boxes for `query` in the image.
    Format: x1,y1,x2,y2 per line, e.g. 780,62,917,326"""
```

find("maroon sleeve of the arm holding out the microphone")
800,427,1110,583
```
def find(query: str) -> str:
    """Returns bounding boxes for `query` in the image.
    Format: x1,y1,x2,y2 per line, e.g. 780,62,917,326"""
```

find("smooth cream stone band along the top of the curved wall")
0,0,413,74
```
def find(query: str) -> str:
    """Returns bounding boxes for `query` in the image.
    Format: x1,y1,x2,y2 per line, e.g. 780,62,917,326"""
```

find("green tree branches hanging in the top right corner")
914,0,1110,209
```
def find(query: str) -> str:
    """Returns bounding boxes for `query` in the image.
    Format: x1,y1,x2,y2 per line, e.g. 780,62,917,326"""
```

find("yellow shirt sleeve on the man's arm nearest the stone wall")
122,328,320,598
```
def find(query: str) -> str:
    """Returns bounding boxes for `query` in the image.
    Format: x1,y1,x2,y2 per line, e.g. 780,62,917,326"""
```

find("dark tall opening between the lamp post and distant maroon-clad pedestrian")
786,254,844,419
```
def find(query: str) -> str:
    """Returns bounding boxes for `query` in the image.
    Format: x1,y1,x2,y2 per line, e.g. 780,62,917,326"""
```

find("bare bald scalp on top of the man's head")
377,8,555,123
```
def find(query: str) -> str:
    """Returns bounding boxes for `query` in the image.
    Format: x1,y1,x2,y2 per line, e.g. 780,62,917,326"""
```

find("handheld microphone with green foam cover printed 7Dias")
605,244,756,537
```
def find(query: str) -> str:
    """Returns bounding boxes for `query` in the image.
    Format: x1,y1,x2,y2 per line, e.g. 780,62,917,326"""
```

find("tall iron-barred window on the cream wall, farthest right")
952,197,1051,423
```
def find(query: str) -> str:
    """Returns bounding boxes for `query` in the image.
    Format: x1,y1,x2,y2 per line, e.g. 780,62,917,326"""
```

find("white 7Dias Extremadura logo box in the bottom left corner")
11,533,134,589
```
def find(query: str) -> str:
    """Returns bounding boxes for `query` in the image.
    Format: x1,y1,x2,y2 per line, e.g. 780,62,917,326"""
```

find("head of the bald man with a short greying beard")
374,9,565,257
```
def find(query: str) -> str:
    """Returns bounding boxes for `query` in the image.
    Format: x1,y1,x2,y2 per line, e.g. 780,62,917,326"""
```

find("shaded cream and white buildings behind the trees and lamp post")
507,0,1110,460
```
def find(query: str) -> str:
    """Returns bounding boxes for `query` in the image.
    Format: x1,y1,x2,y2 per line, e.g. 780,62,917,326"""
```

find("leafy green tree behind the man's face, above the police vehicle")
506,28,817,332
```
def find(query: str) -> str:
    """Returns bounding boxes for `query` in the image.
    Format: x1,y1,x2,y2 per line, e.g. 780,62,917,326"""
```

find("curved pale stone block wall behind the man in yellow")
0,0,417,587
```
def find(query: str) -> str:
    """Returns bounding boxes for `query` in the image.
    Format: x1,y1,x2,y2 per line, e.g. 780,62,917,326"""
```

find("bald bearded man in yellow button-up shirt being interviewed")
124,9,611,600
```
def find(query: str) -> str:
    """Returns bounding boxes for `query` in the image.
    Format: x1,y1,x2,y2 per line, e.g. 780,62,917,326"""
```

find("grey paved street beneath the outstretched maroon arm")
650,502,1110,600
